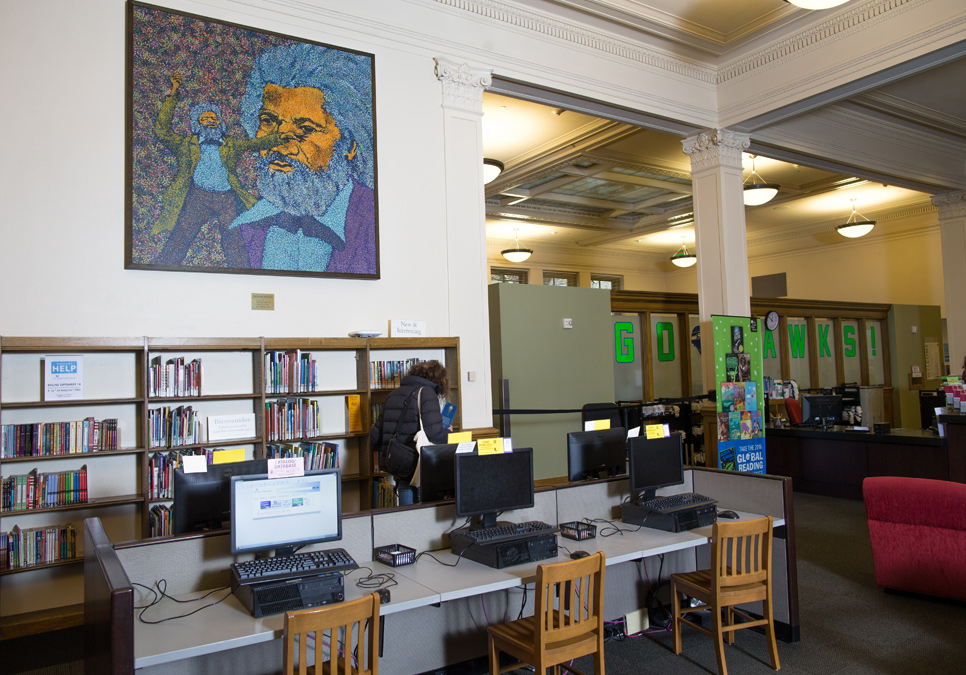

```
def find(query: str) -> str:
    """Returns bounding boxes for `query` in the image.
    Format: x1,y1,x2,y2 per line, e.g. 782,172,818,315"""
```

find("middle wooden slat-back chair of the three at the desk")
488,553,604,675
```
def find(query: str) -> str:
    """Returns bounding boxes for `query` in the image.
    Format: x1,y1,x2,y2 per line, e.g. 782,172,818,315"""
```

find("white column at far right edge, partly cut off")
932,191,966,375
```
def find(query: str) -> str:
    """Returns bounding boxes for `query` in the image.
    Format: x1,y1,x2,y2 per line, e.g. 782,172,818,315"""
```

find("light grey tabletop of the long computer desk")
134,512,784,668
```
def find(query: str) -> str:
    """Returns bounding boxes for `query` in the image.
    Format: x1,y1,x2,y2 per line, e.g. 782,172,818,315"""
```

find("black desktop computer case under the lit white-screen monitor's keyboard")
231,572,345,617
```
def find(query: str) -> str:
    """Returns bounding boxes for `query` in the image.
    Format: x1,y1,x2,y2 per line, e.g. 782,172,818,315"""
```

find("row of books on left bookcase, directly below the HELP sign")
0,417,121,458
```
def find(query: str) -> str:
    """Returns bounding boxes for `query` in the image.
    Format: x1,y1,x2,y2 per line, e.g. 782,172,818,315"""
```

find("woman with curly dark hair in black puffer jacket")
369,361,449,506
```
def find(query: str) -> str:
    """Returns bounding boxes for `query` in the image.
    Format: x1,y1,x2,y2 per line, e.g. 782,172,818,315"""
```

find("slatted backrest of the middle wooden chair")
533,552,604,651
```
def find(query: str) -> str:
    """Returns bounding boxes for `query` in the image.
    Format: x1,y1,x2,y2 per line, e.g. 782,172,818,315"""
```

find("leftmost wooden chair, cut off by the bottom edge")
282,593,379,675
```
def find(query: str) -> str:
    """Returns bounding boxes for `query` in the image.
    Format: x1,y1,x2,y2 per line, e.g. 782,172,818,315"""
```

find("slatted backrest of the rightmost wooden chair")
711,516,772,589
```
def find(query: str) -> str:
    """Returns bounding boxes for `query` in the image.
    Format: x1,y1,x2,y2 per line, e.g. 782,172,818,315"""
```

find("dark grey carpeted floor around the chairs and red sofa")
7,494,966,675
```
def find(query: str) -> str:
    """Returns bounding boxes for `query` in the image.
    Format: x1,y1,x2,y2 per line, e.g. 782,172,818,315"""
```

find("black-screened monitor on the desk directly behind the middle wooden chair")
455,448,533,529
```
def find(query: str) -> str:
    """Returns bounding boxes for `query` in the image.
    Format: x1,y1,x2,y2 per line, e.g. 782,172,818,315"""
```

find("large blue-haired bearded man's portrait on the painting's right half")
230,43,378,276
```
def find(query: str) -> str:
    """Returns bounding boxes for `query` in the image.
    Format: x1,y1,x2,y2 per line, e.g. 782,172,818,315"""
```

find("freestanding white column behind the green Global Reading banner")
682,129,751,389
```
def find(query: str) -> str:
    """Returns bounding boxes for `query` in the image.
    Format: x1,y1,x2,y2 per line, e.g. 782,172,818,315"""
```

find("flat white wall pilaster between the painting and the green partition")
434,57,493,428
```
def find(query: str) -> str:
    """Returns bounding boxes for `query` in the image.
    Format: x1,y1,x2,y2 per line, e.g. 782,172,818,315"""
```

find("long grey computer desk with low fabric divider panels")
104,469,798,675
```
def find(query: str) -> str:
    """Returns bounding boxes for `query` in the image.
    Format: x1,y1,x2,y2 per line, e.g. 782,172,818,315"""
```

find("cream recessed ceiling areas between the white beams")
483,0,966,268
